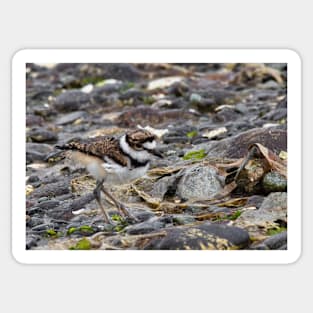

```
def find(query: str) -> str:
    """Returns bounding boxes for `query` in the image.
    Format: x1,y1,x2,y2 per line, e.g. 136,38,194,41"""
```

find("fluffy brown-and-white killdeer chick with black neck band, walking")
56,129,162,223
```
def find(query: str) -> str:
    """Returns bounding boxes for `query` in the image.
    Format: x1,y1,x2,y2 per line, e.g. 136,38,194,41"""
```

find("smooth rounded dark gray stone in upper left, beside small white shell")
54,90,90,112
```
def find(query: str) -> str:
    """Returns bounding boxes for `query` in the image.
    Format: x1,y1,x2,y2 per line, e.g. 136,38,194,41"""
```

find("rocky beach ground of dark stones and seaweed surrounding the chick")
25,64,286,250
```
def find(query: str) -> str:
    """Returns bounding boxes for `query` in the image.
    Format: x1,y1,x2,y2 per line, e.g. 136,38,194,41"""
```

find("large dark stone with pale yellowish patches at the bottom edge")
144,223,250,250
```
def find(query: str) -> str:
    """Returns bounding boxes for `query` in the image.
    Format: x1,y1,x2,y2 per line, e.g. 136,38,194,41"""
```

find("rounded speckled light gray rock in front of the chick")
176,165,224,200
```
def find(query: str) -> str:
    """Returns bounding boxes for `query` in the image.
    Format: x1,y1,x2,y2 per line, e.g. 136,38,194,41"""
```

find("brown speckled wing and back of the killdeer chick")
58,136,127,166
